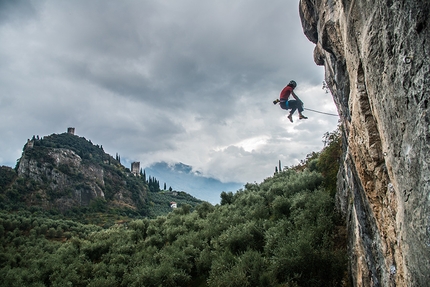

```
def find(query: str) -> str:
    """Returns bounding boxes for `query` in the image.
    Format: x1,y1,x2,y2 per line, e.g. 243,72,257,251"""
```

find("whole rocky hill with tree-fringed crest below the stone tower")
2,133,148,212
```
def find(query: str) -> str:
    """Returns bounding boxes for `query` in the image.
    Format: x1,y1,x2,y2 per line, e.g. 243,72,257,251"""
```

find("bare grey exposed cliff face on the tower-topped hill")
18,147,138,212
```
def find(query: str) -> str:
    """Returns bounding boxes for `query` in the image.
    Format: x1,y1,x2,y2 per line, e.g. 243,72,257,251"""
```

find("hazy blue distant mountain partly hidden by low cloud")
145,162,244,204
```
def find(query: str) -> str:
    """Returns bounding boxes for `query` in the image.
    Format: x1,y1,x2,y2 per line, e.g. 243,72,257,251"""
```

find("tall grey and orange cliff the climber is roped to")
300,0,430,286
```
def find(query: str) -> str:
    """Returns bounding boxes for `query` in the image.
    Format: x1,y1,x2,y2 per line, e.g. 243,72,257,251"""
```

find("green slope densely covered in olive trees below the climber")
0,131,347,287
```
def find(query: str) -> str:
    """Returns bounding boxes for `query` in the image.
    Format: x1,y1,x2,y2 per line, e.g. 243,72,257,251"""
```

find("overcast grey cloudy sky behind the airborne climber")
0,0,338,187
